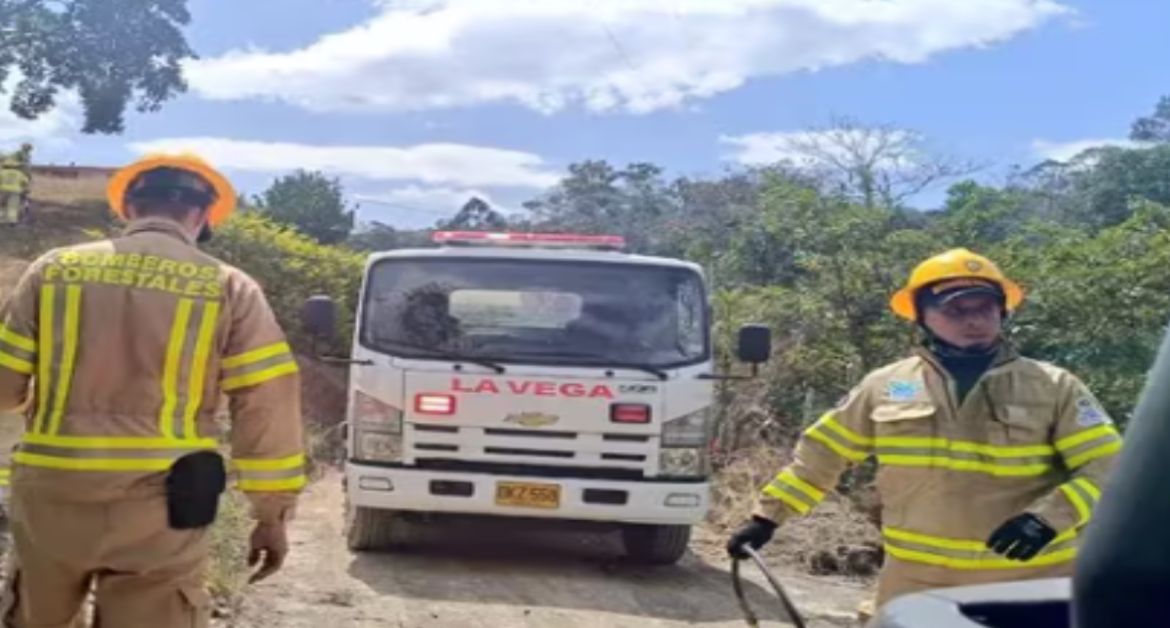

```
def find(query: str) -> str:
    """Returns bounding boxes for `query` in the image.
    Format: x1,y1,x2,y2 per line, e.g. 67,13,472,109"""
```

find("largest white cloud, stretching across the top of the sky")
187,0,1073,112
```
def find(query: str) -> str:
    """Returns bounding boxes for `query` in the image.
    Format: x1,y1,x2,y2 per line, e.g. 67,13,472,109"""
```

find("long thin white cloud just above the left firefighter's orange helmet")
130,137,559,188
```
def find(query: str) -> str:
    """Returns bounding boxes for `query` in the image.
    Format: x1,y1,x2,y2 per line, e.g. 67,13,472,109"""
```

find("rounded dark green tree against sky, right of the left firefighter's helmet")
255,170,355,244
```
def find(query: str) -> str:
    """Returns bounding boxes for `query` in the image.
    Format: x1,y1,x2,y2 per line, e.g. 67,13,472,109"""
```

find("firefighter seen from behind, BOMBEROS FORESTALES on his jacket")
0,156,305,628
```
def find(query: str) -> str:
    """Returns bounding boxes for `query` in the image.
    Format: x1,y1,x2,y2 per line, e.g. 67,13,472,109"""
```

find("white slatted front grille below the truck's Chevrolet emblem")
406,423,658,478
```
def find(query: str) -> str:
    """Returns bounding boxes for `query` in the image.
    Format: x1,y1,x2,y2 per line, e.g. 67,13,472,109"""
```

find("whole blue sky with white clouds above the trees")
0,0,1170,227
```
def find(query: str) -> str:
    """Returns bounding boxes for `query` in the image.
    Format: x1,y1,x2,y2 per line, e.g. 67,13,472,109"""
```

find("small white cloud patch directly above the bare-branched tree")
720,127,922,170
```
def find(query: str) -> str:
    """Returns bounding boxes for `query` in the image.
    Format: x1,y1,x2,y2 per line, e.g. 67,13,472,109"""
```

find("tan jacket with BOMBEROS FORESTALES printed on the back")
0,219,305,522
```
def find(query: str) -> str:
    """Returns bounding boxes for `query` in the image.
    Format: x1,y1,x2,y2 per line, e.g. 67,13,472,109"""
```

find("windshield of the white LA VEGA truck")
360,258,709,368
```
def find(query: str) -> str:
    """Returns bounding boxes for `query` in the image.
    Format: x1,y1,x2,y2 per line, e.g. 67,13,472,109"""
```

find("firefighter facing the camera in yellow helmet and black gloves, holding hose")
728,249,1121,606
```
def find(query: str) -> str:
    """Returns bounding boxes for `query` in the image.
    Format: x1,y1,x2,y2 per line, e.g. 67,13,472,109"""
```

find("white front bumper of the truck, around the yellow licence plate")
345,462,710,525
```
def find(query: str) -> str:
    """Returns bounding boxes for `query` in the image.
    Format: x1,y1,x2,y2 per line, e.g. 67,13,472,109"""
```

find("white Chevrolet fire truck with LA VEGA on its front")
304,232,771,564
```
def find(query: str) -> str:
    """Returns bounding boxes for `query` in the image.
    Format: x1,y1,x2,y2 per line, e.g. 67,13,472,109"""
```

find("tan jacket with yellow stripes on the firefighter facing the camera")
756,347,1121,605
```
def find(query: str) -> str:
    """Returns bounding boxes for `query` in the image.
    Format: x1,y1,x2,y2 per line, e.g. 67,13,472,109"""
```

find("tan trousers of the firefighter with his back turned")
0,482,211,628
